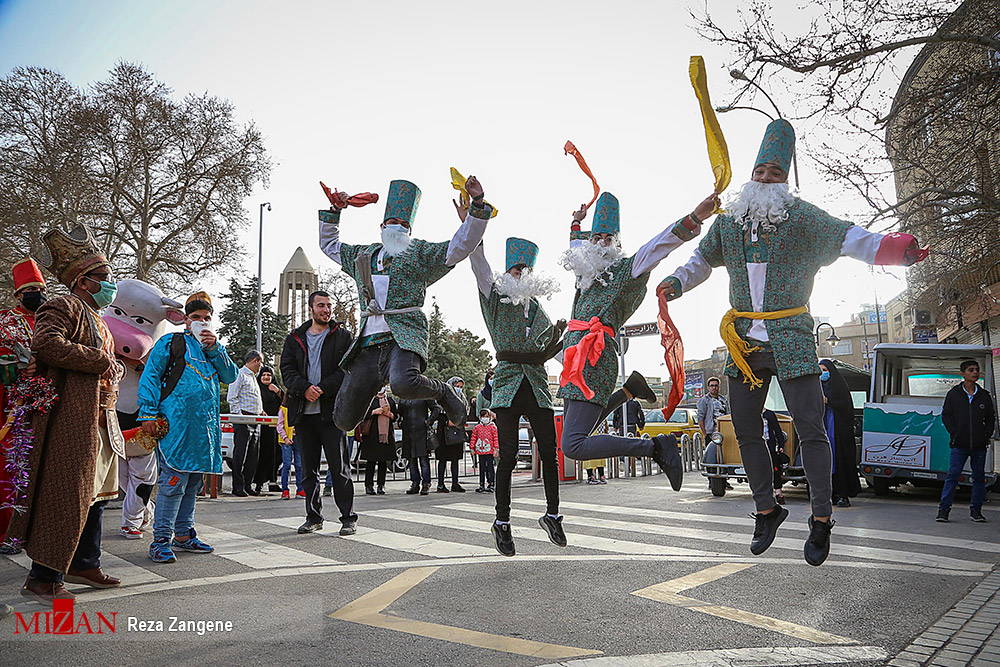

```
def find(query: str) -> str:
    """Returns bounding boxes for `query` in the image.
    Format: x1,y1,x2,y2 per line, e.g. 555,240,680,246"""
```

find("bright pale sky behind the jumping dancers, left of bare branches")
0,0,903,375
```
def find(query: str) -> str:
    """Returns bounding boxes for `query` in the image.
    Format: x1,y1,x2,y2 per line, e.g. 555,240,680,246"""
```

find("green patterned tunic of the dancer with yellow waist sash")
698,199,852,380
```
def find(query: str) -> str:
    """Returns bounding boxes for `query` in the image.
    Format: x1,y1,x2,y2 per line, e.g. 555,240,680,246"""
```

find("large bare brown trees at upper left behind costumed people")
0,62,271,306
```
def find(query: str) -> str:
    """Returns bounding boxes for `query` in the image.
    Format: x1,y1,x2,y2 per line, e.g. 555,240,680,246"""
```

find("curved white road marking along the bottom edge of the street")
541,646,889,667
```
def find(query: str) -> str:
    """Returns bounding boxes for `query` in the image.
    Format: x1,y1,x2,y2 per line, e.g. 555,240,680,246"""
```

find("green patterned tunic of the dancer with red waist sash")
557,255,649,406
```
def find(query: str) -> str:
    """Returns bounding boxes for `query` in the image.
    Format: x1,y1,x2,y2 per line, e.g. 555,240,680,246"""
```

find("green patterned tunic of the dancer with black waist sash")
479,287,552,409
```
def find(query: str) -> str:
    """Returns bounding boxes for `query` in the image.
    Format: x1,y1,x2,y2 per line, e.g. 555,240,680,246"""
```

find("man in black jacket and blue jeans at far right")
937,359,996,523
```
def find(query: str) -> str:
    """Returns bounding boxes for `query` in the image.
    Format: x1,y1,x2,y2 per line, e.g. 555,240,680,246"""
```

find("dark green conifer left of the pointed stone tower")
218,276,290,371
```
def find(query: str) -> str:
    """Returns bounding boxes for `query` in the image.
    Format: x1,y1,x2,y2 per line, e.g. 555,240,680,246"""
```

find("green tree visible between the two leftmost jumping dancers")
426,301,493,404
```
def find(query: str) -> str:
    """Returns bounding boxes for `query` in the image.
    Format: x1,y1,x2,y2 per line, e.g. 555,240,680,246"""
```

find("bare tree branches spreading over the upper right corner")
694,0,1000,312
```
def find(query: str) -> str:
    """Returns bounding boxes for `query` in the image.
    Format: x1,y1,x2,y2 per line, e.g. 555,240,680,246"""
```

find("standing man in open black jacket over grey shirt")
281,291,358,535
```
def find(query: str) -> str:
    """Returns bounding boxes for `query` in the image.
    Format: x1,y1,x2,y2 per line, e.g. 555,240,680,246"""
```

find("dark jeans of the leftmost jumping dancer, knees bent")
333,340,452,432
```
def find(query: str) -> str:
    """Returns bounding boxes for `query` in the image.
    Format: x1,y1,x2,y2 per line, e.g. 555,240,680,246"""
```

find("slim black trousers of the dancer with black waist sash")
493,378,559,521
